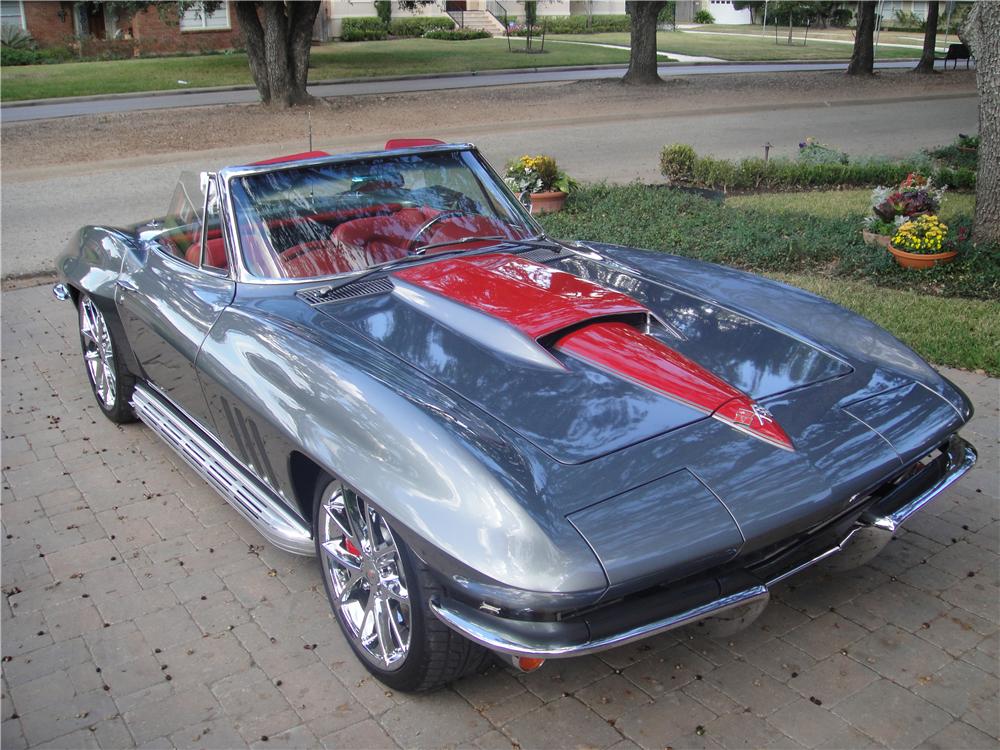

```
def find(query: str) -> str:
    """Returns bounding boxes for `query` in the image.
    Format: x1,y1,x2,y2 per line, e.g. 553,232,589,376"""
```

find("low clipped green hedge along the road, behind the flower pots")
660,144,976,192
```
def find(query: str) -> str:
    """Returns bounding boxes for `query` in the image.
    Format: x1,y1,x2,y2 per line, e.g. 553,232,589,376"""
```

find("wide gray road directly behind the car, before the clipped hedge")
0,91,977,276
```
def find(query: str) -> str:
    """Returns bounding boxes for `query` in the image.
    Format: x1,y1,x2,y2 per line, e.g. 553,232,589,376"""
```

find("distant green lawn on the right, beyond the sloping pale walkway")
551,31,920,62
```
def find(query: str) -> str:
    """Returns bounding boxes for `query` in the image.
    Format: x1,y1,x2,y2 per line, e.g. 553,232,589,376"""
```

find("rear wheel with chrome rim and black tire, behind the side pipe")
77,294,136,424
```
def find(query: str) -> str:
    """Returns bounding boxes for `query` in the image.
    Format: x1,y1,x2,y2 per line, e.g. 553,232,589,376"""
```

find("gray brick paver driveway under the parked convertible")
2,287,1000,749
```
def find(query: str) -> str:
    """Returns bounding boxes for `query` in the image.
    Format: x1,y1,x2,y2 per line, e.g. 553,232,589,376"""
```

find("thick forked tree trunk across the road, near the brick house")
233,0,320,108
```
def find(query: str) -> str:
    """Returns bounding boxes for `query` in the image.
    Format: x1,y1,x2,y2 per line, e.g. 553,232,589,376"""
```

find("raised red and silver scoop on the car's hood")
394,254,794,450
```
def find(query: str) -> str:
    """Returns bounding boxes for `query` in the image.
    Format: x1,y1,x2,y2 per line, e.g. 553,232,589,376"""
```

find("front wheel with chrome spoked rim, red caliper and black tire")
313,480,490,692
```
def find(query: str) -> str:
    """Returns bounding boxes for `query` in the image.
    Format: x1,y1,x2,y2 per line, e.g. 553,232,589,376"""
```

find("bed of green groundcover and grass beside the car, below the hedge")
541,184,1000,376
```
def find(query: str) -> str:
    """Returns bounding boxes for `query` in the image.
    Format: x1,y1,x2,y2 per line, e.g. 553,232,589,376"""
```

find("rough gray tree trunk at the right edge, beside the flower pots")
959,2,1000,245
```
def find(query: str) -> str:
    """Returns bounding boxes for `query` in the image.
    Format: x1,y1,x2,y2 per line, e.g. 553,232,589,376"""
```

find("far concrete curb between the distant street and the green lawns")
0,58,917,111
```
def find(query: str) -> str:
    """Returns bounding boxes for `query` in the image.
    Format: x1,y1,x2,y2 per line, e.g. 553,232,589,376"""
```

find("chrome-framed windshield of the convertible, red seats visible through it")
230,151,538,279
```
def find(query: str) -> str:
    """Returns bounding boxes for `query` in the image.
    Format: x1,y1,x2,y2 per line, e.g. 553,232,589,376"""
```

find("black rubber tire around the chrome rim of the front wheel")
313,477,493,692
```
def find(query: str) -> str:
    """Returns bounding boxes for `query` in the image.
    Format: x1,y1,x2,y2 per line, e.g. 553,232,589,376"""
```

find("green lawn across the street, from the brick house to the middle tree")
0,39,628,102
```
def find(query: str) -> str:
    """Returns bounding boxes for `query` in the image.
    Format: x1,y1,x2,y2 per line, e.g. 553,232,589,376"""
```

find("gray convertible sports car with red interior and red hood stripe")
55,141,976,690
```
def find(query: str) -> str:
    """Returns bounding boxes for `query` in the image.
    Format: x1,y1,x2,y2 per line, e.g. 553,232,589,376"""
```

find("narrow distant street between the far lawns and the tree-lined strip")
0,60,944,122
